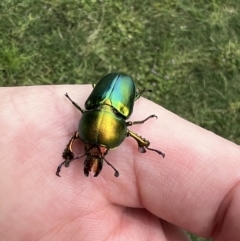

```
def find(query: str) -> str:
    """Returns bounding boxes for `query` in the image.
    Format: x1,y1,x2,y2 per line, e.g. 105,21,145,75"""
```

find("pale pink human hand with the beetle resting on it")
0,85,240,241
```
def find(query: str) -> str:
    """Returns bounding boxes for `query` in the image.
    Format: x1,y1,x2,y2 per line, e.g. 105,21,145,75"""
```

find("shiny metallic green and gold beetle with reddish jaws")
56,73,165,177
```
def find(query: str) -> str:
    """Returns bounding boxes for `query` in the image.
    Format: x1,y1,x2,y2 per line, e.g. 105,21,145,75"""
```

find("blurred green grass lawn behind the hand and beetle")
0,0,240,240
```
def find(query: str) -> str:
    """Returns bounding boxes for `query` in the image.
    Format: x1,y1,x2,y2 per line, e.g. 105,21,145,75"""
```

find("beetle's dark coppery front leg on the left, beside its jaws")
56,132,79,177
